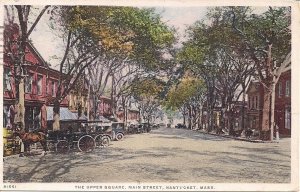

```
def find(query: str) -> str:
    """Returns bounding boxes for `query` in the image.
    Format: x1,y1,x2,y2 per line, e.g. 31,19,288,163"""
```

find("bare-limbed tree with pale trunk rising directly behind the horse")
4,5,49,130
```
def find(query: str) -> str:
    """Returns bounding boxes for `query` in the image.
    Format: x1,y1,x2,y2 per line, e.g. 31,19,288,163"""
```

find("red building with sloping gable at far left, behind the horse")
3,24,68,130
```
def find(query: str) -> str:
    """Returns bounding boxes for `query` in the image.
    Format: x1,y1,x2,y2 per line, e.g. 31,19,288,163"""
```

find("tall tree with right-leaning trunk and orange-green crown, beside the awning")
49,6,174,127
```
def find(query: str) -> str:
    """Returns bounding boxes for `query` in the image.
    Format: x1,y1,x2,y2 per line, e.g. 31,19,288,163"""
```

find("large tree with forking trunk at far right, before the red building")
228,7,291,141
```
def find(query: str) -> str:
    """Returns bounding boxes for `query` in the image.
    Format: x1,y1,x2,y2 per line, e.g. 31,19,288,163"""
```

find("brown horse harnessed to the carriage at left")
14,131,47,156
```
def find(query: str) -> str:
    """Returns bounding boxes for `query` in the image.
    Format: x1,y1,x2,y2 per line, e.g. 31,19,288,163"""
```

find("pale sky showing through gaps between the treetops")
30,7,206,68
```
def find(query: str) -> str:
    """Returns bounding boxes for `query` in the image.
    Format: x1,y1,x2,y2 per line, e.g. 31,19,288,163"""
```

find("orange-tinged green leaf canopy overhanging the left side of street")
57,6,175,70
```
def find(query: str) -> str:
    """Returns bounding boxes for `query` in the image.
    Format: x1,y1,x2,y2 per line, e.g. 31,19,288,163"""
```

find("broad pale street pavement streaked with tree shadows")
3,128,291,183
